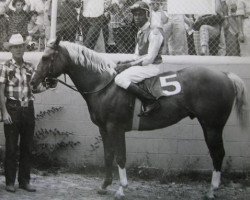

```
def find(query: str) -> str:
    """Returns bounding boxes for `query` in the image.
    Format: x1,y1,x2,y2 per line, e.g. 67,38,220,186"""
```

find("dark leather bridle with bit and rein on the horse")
44,44,115,95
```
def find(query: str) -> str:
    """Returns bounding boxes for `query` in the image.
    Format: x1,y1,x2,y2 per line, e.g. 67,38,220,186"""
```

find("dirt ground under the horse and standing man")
0,173,250,200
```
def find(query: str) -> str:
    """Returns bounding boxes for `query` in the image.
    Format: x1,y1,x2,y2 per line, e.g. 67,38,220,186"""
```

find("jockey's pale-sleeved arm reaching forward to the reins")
131,29,163,66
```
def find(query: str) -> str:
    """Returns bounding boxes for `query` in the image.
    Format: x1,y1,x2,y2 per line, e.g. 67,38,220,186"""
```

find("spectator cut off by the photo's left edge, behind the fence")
0,0,11,51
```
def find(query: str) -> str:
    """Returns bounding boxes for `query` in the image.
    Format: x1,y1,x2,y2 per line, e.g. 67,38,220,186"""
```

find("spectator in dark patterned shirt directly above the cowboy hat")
6,0,30,38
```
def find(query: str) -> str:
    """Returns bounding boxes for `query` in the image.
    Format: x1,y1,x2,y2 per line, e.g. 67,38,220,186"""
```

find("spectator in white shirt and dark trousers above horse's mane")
80,0,110,49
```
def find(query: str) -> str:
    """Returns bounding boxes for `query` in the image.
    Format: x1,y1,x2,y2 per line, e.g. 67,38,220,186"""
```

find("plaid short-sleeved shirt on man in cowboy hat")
0,59,34,101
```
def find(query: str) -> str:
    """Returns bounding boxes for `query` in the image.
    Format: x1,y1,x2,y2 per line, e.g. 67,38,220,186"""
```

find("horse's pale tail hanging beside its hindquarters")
227,73,249,128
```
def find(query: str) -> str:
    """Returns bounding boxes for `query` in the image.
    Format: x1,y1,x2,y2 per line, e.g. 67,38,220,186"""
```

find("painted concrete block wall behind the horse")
0,53,250,171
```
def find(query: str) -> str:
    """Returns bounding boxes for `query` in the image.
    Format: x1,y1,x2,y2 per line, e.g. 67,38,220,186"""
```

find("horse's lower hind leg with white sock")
203,126,225,198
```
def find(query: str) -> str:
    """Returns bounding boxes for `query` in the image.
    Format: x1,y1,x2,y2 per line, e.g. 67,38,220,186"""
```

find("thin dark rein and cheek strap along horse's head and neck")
47,46,115,95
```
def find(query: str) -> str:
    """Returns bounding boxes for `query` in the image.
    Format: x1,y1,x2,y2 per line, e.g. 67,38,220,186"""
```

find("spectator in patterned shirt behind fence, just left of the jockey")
109,0,136,53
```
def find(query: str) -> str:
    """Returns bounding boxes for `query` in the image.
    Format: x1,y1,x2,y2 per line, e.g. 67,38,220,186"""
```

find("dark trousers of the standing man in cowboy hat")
4,99,35,185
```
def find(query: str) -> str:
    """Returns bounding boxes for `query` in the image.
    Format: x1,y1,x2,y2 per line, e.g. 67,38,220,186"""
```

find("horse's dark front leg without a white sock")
98,129,115,194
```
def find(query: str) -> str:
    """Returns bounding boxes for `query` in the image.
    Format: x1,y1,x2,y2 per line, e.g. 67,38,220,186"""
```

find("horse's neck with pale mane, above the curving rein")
62,43,115,92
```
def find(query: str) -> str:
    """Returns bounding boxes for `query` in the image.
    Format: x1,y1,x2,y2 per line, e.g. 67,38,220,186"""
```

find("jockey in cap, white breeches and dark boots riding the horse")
115,1,163,116
